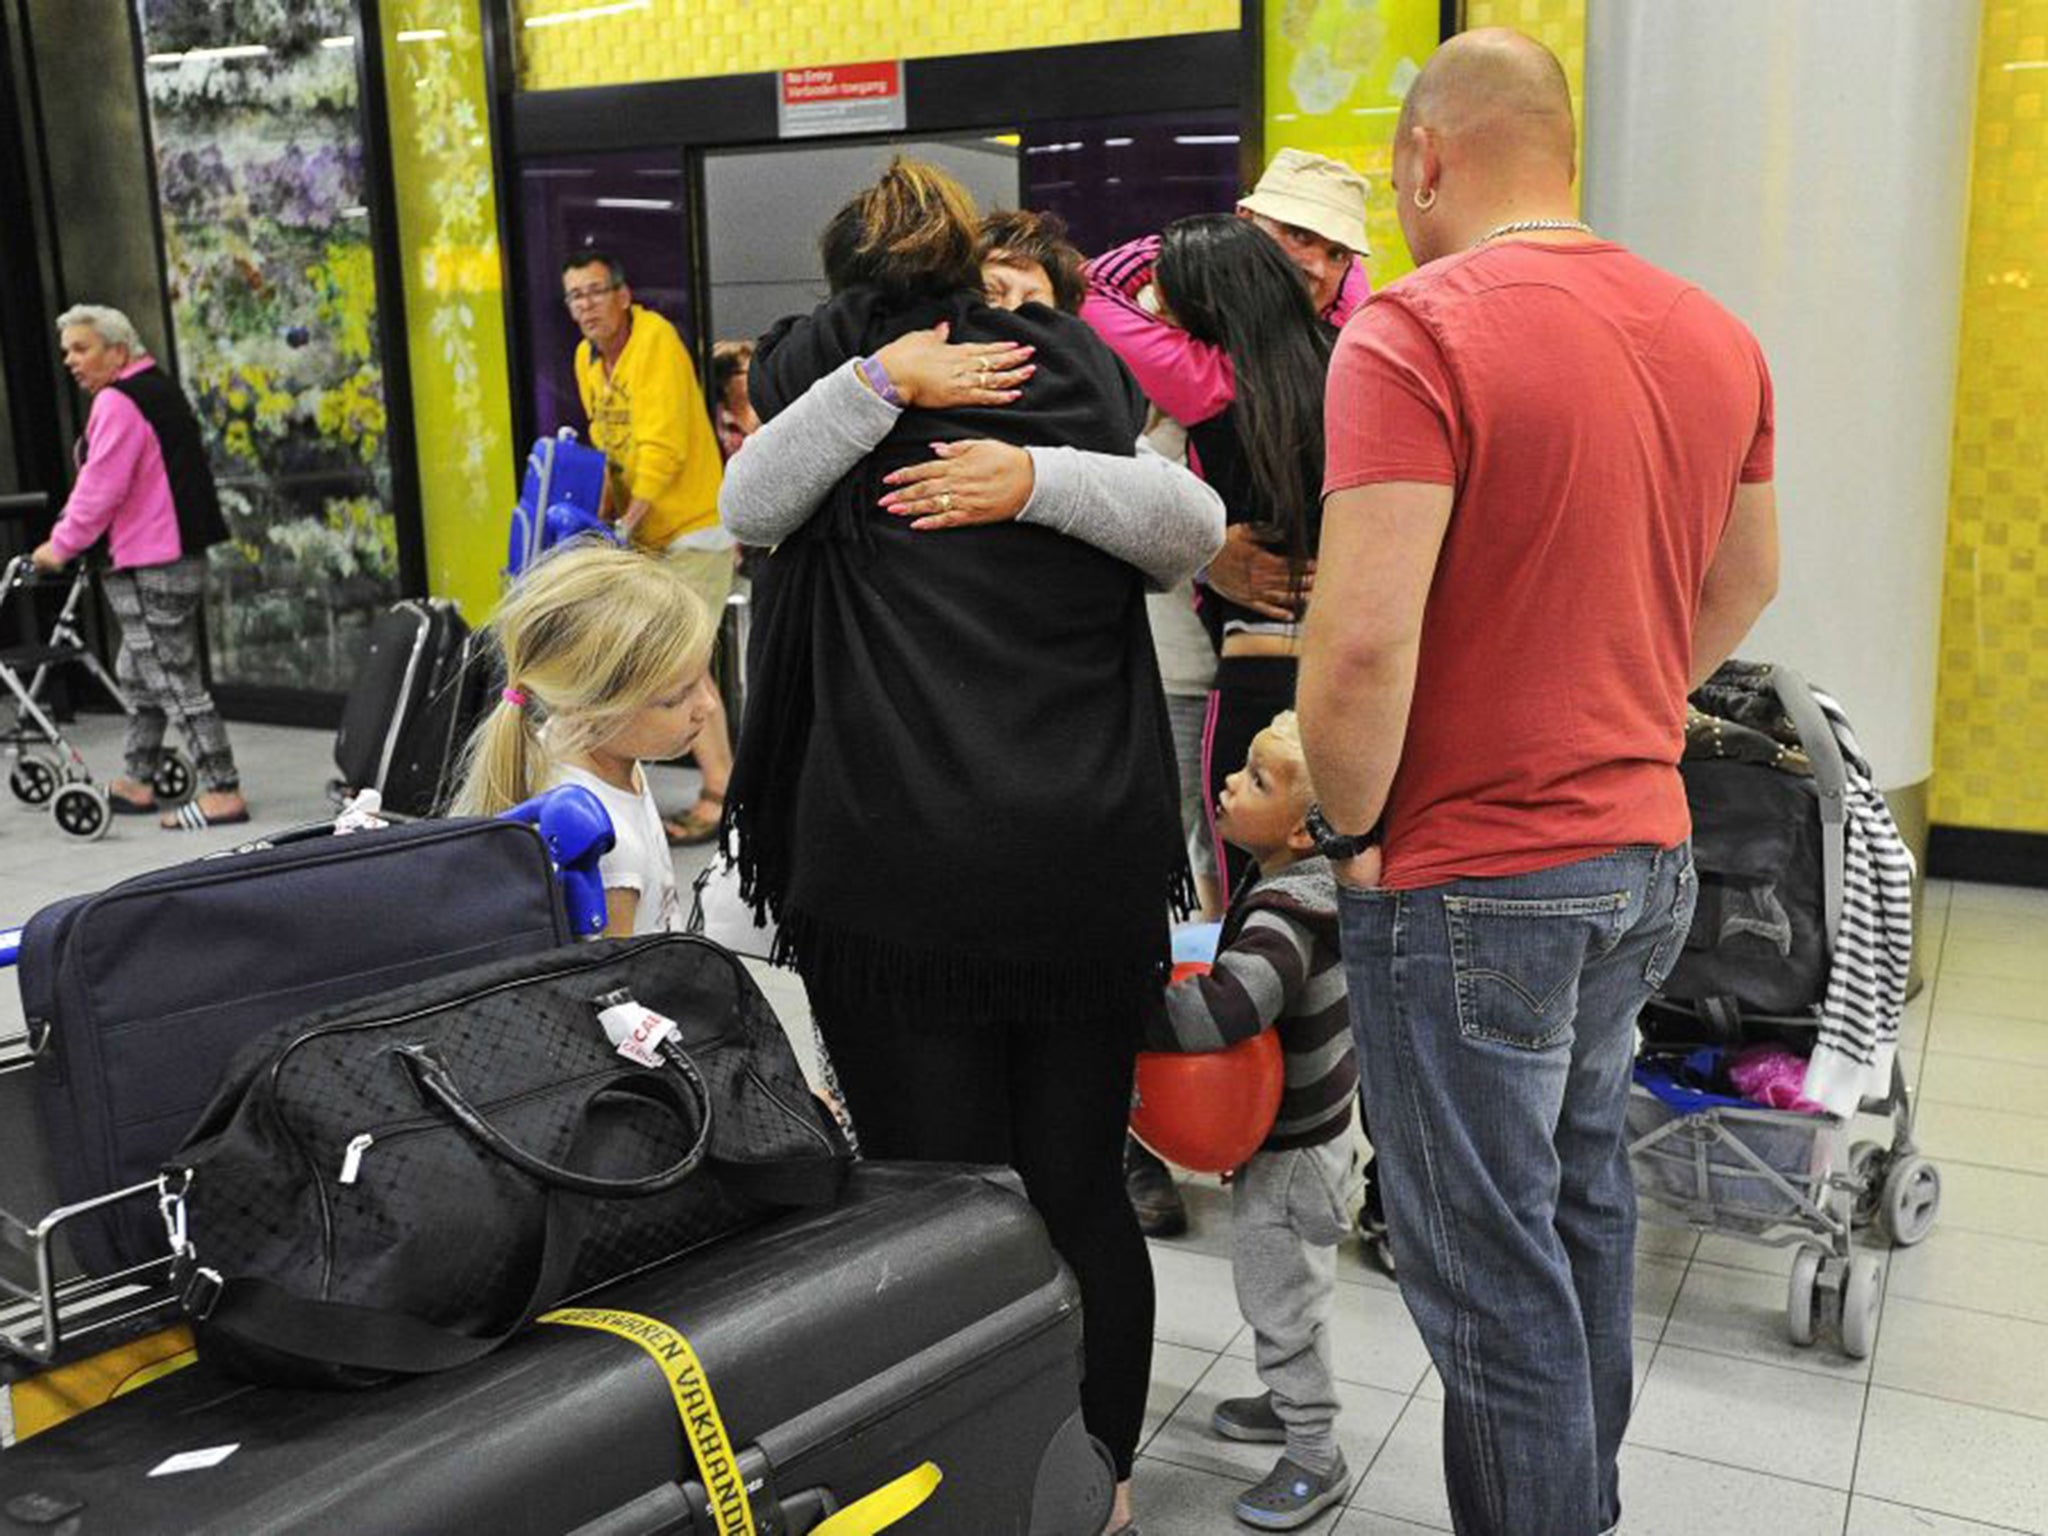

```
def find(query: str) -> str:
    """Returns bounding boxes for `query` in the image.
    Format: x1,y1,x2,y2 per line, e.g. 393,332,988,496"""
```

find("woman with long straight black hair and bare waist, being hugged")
1153,213,1329,891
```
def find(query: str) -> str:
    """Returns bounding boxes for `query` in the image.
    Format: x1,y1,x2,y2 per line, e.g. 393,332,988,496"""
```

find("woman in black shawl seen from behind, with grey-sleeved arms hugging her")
721,162,1223,1530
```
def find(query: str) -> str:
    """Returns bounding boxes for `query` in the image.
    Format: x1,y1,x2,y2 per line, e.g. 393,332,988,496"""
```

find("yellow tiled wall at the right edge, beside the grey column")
1933,0,2048,831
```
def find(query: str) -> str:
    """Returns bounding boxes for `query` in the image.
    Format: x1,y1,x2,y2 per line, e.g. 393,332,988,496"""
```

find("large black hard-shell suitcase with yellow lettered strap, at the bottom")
0,1163,1112,1536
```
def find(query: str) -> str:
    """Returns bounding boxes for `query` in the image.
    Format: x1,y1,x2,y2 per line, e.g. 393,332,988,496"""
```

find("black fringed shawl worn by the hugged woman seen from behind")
725,289,1190,1026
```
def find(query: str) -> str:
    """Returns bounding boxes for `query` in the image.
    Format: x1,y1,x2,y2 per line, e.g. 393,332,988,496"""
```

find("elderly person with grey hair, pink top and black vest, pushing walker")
33,303,250,831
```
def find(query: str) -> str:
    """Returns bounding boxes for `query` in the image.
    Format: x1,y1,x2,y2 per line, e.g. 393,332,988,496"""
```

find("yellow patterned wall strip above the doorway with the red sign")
512,0,1239,90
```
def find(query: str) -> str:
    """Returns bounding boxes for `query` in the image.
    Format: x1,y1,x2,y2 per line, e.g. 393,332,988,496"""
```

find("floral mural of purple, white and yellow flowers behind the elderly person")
137,0,399,690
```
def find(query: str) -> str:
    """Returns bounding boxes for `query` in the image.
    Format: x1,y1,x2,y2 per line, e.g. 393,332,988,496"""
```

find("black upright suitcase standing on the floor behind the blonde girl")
334,598,494,815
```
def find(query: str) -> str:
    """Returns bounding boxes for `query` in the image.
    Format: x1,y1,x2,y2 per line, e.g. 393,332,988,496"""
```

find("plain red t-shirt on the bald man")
1317,242,1772,887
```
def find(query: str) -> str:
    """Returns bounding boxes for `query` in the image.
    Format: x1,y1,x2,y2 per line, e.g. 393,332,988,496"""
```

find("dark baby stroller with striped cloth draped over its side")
1628,662,1942,1360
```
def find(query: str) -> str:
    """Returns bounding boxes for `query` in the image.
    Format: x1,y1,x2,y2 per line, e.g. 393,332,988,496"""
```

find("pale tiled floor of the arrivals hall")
0,721,2048,1536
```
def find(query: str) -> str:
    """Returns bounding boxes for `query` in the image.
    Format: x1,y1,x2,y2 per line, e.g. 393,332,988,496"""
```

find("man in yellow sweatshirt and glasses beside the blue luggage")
561,250,733,846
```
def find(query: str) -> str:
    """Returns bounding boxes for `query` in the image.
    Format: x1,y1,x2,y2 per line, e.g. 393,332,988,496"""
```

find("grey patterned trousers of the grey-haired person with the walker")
100,557,242,795
